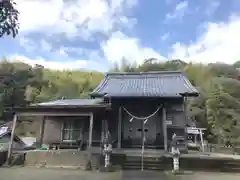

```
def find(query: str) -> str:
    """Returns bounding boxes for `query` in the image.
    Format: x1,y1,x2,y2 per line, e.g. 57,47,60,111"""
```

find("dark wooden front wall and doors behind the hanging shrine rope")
108,98,186,148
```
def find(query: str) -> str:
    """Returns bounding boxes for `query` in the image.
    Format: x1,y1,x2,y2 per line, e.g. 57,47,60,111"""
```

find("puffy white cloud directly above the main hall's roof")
102,32,163,64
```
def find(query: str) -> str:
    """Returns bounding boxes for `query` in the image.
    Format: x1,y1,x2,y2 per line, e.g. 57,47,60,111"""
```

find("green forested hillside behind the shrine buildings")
0,59,240,150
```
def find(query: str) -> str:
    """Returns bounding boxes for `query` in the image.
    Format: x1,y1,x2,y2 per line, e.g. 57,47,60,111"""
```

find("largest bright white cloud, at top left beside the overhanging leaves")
17,0,137,39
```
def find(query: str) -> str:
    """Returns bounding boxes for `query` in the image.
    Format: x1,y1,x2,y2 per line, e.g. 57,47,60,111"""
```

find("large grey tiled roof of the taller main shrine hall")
90,71,199,97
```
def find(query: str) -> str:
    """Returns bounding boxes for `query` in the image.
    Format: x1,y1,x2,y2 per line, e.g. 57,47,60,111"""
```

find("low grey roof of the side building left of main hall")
32,99,103,107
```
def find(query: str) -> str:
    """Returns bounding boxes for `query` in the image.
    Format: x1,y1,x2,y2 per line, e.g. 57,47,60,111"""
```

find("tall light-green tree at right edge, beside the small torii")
206,79,240,149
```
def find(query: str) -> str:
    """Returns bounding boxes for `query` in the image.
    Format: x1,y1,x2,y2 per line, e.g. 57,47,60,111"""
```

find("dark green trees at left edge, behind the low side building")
0,61,42,120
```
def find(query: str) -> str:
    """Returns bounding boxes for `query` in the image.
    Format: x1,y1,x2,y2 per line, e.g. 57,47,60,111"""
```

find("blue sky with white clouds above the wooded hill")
0,0,240,71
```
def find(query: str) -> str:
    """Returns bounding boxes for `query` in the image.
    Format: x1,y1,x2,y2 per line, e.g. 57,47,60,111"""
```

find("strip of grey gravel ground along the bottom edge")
0,167,240,180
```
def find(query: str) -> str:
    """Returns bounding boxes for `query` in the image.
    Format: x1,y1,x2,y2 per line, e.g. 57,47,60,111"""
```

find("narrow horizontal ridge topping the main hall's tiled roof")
106,71,183,76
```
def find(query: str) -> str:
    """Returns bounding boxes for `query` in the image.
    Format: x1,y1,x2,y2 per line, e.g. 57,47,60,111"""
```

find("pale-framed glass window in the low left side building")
62,118,84,141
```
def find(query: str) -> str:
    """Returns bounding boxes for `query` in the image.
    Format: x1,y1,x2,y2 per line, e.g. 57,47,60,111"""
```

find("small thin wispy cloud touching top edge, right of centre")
165,1,188,21
